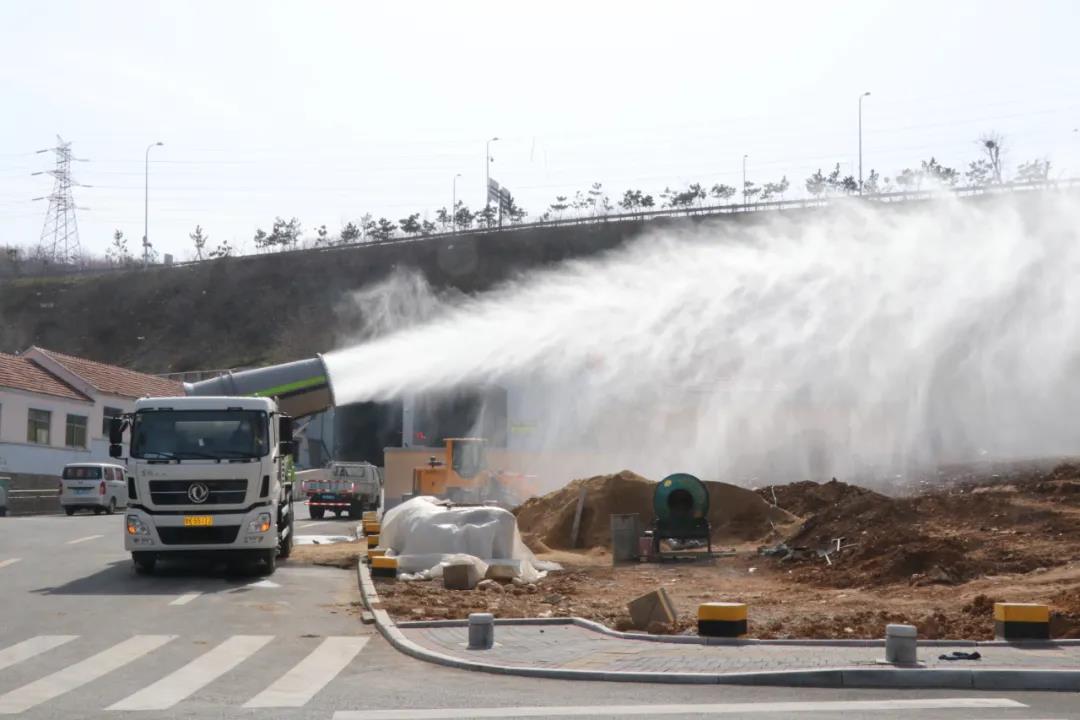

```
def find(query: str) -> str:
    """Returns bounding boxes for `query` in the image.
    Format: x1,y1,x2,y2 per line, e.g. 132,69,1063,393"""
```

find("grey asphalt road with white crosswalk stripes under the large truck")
0,505,1080,720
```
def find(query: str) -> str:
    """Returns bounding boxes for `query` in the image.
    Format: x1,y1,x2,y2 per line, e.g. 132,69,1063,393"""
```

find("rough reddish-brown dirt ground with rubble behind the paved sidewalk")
369,464,1080,639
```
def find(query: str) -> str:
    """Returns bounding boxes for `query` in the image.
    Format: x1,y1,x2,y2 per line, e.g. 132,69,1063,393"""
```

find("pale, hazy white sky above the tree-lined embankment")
0,0,1080,260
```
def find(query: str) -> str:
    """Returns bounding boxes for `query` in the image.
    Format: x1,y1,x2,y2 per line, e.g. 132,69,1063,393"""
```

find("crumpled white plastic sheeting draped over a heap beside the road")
379,495,559,583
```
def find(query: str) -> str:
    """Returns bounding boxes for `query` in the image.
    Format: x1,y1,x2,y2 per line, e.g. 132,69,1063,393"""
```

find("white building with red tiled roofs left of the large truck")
0,348,184,488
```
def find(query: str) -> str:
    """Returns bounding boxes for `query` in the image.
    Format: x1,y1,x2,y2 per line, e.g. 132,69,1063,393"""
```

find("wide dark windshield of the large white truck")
131,410,270,460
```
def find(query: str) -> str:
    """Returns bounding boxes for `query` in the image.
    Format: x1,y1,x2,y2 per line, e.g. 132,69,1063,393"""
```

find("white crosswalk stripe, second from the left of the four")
0,635,176,715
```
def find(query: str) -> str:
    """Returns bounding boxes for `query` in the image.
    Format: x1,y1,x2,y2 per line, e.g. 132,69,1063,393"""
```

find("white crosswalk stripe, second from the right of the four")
108,635,273,710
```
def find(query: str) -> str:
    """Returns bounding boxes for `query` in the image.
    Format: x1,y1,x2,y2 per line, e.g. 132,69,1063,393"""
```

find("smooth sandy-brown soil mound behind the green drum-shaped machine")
514,470,796,553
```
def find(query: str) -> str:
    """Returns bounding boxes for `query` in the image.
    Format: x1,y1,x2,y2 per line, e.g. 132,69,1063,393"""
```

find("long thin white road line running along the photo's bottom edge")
334,697,1027,720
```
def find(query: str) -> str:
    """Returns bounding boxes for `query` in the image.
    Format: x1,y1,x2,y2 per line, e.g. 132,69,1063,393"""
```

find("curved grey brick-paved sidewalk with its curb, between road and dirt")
360,565,1080,691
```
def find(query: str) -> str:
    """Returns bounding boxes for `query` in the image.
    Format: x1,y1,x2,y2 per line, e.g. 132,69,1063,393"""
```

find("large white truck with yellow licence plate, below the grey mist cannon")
109,396,295,574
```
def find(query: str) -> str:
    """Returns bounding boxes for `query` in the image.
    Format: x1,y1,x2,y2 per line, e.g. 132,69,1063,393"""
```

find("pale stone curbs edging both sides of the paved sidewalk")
356,561,1080,692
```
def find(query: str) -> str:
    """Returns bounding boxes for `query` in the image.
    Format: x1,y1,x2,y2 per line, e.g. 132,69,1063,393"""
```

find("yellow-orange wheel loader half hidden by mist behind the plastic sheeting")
413,437,534,507
